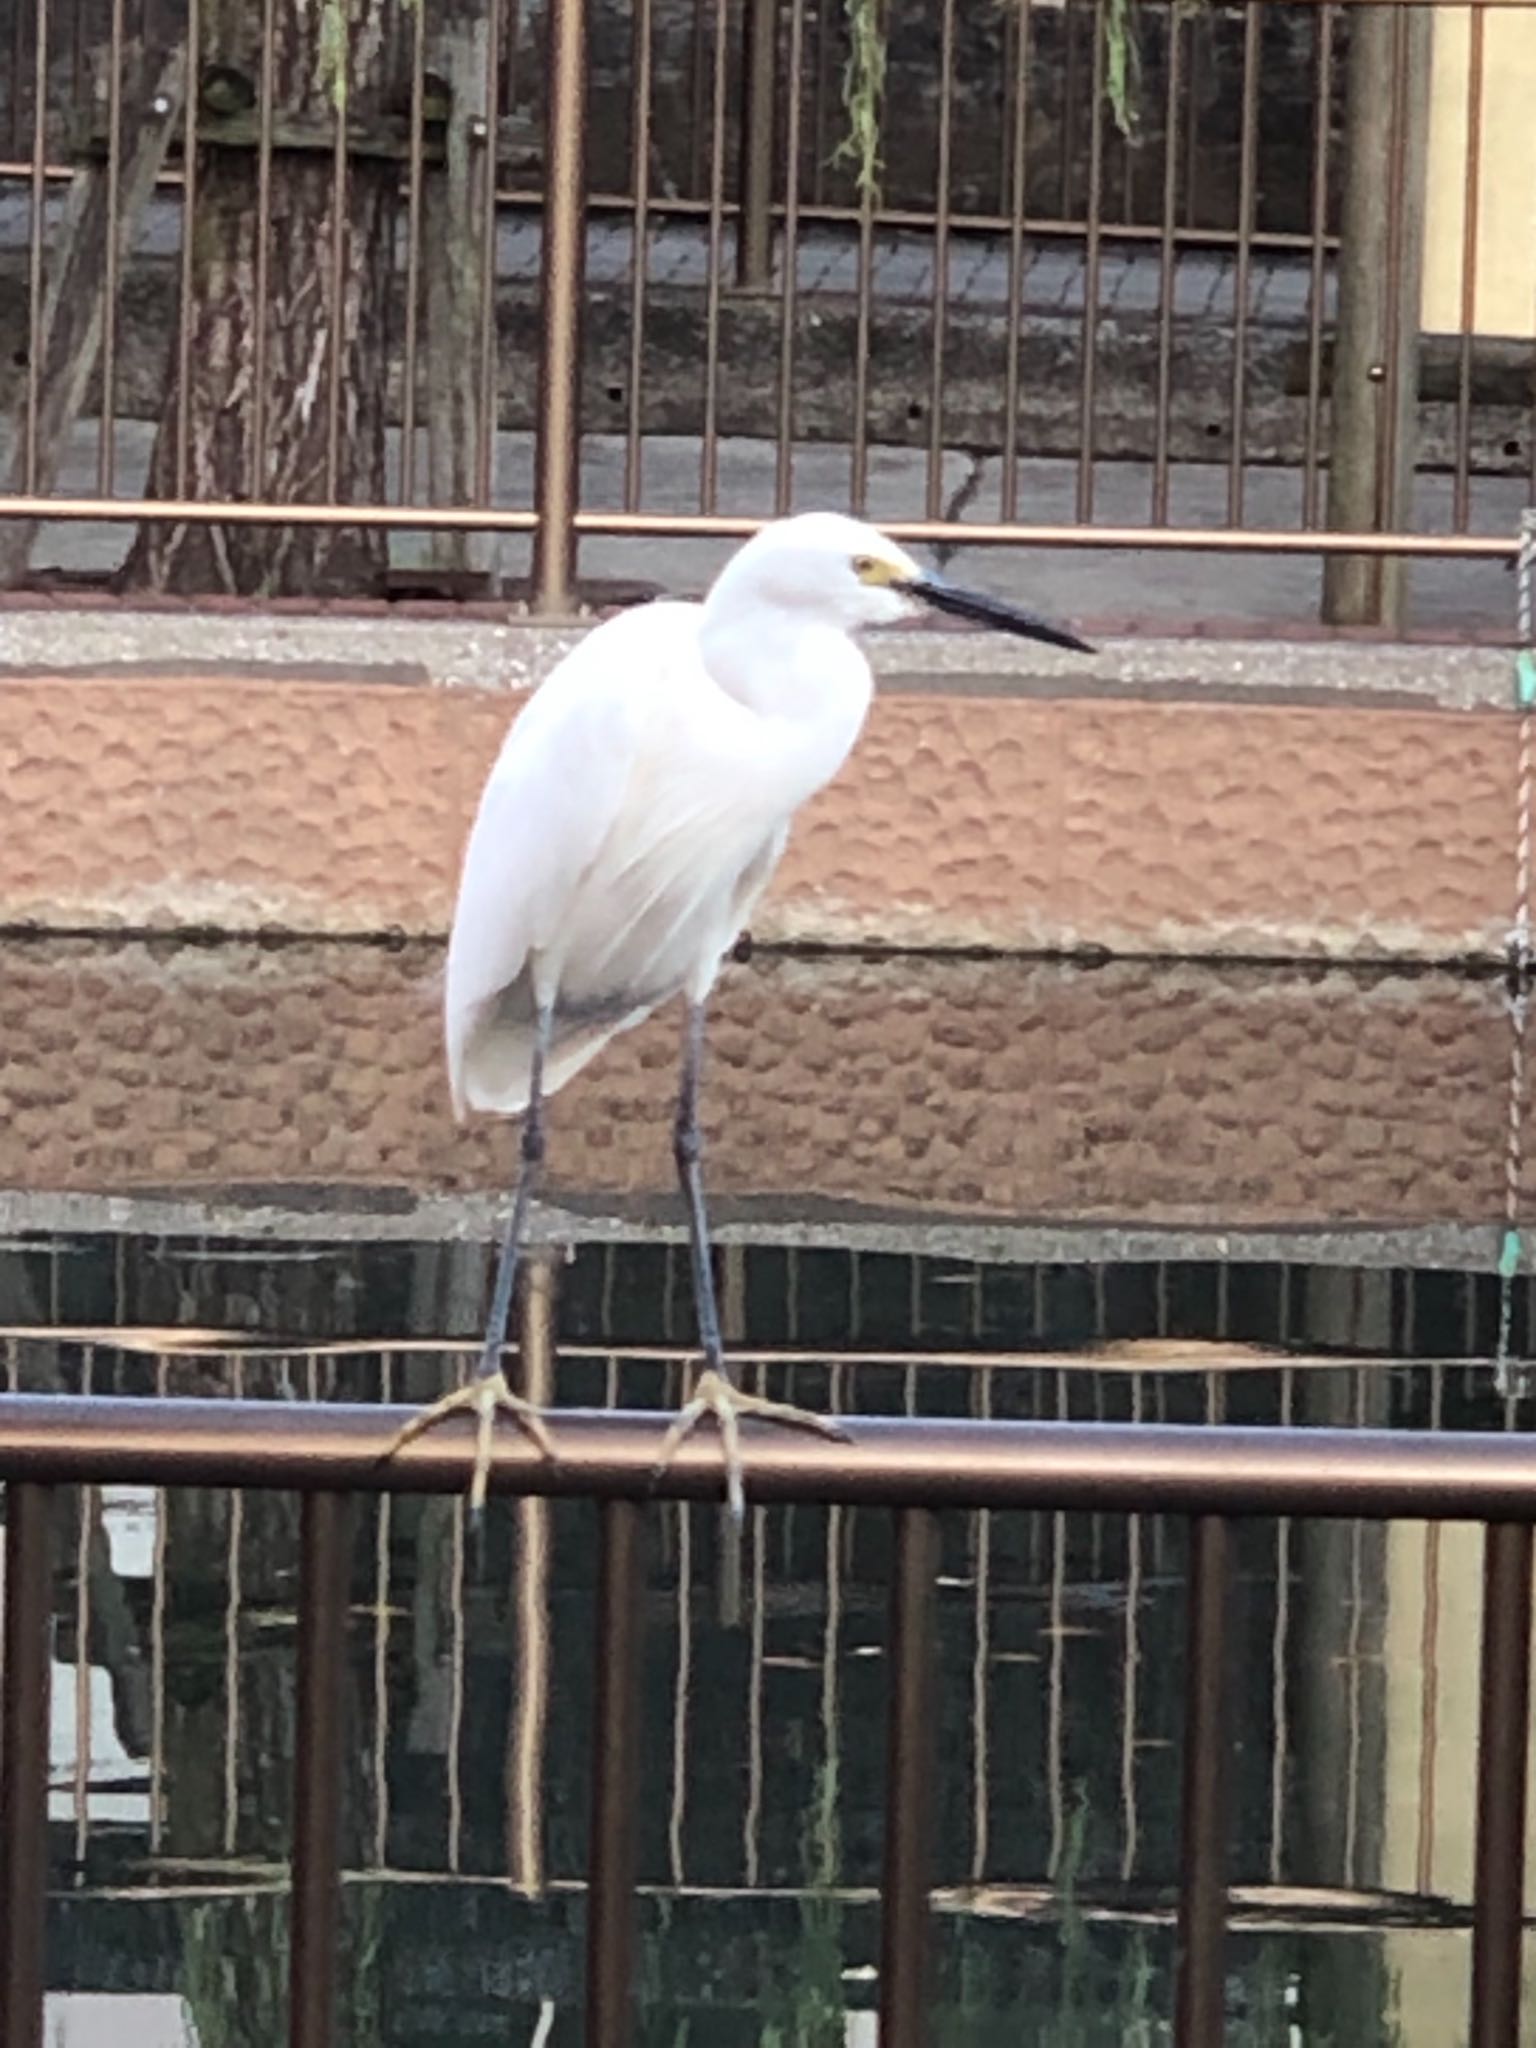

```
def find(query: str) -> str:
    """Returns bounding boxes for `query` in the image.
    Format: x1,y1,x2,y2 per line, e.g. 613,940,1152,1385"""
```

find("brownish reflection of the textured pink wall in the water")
0,940,1536,1228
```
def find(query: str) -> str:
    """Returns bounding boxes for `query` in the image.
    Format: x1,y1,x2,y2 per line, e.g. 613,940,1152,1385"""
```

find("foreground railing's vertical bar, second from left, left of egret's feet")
289,1493,346,2048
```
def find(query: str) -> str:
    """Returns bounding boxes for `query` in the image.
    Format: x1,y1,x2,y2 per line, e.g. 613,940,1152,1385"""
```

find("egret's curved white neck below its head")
698,600,872,752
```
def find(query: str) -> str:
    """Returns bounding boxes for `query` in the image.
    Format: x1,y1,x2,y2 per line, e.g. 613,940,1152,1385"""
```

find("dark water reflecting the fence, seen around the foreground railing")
0,1239,1520,2048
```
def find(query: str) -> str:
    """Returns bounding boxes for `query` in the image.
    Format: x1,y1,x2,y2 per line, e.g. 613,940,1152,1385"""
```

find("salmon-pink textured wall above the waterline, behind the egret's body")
0,625,1518,961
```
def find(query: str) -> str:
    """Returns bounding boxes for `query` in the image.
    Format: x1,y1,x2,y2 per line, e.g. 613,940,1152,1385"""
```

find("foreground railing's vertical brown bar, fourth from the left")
881,1507,938,2048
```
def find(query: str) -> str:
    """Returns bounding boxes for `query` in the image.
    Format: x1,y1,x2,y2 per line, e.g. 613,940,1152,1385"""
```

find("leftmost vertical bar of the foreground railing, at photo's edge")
0,1481,53,2048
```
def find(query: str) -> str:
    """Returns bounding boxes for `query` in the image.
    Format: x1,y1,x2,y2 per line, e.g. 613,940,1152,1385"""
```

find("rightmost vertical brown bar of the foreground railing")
1468,1522,1532,2048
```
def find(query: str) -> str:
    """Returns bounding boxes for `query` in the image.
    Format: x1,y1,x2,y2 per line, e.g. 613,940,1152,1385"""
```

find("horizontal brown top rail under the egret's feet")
18,1395,1536,1522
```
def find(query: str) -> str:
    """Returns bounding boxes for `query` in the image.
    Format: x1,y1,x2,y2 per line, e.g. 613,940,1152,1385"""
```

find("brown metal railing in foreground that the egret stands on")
0,1395,1536,2048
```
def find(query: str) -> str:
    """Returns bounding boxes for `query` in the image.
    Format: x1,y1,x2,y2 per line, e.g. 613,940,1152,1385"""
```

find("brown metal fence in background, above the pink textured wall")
0,0,1536,621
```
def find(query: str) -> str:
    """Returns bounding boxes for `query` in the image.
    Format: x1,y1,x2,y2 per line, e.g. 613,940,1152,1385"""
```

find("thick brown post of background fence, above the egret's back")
532,0,586,614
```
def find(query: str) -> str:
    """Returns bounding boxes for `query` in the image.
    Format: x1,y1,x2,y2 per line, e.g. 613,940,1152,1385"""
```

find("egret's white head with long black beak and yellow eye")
709,512,1092,653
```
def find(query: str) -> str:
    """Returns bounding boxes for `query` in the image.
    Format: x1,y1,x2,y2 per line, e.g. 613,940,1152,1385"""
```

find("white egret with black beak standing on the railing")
395,512,1090,1516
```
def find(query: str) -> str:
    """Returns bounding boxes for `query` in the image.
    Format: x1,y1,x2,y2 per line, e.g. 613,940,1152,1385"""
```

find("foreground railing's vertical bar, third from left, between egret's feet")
586,1499,645,2048
